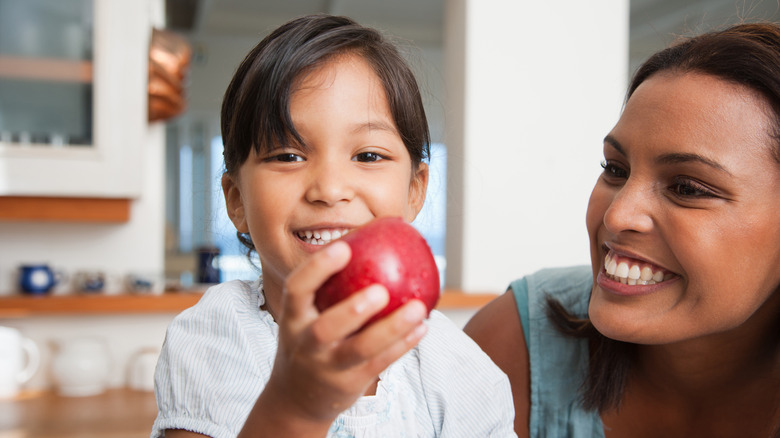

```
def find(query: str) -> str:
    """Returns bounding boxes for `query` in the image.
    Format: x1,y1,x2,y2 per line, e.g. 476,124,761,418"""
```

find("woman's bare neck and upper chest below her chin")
601,293,780,438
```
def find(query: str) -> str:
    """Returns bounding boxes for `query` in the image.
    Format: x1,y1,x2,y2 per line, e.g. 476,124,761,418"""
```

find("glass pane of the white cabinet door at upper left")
0,0,93,147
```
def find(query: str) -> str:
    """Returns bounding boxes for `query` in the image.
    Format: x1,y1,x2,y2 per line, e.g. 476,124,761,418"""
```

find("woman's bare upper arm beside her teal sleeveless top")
463,290,531,438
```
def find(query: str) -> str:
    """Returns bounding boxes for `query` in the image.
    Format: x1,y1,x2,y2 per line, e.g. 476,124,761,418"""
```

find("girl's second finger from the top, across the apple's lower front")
312,284,390,344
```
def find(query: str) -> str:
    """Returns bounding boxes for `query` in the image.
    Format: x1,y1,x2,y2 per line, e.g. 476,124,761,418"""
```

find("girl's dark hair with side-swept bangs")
221,14,431,252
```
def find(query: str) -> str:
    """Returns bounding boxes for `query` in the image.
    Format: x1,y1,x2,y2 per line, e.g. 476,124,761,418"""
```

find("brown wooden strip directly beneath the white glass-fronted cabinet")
0,196,130,223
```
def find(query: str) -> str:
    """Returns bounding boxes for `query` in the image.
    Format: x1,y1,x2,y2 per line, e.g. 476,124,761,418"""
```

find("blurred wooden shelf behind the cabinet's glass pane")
0,56,92,84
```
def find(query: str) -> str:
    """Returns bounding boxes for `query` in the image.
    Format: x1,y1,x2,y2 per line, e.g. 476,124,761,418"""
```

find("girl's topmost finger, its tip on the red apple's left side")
282,241,351,318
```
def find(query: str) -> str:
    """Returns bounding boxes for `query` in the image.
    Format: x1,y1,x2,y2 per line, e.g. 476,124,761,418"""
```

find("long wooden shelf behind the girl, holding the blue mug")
0,290,496,318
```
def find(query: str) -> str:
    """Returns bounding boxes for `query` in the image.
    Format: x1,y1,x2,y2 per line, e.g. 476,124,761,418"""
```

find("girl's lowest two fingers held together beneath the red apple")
337,300,427,369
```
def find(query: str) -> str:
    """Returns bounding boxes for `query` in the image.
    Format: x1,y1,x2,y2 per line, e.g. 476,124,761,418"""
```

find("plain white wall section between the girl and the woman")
445,0,629,292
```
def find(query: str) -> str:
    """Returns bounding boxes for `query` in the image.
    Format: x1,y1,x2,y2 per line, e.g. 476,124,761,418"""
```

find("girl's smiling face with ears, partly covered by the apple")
223,55,428,293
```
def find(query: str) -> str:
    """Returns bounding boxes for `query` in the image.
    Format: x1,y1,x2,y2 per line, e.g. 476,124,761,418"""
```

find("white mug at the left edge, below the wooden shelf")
0,327,41,398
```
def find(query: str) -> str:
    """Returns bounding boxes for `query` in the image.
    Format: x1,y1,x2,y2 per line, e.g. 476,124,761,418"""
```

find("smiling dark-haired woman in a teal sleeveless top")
466,24,780,438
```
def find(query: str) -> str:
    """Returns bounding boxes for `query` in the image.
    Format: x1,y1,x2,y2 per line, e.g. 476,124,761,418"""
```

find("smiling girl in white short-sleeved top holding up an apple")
152,15,515,437
